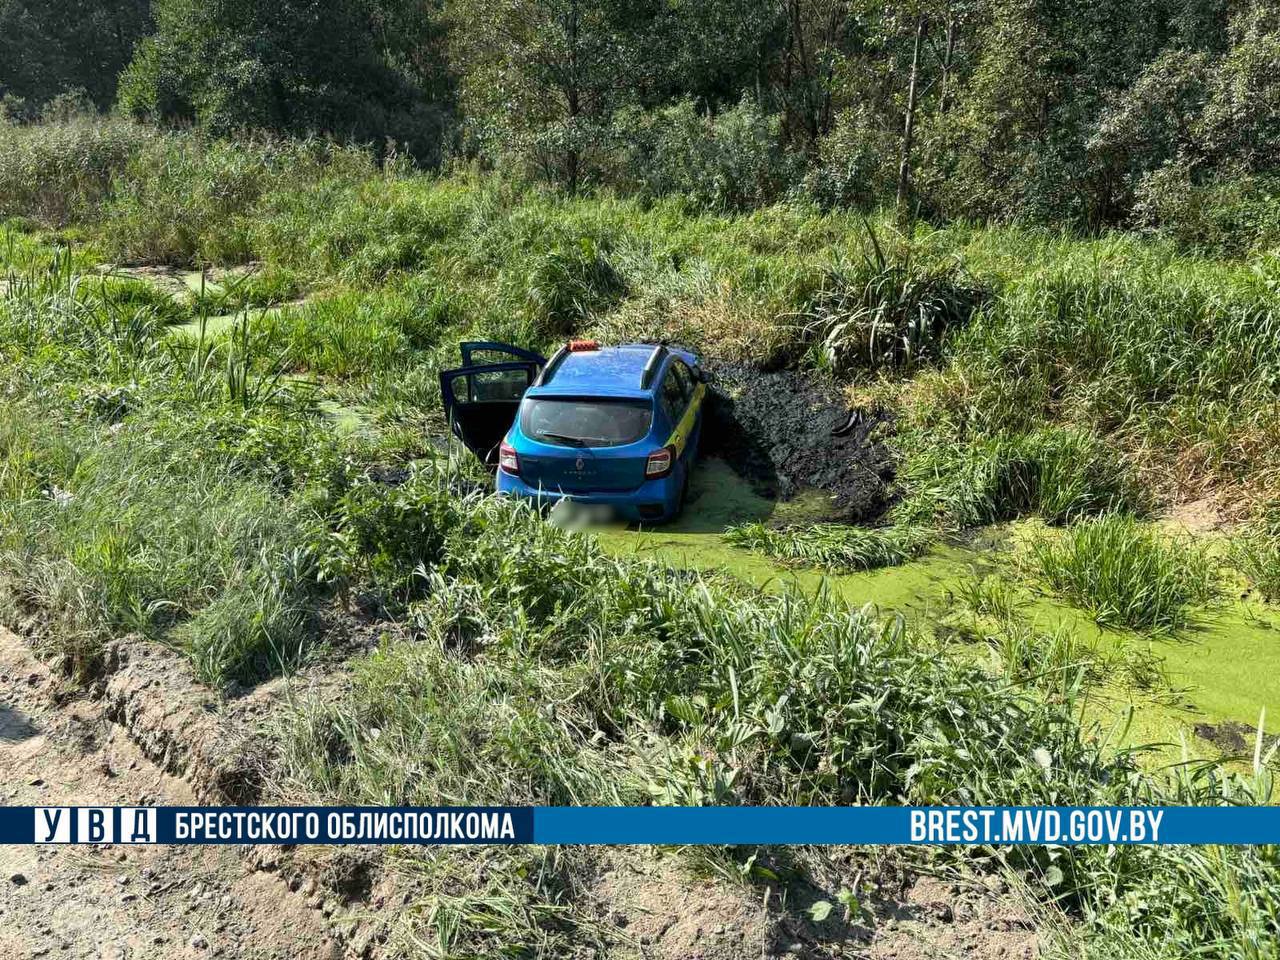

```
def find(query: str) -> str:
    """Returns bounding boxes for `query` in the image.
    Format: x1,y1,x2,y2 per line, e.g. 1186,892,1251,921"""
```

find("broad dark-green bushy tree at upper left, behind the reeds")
120,0,442,161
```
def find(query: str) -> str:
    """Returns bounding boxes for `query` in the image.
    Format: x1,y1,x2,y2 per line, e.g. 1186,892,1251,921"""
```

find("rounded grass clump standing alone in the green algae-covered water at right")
1034,515,1217,631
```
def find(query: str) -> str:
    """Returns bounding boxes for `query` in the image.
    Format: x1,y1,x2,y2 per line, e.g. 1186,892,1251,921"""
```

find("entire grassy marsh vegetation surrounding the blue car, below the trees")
0,124,1280,957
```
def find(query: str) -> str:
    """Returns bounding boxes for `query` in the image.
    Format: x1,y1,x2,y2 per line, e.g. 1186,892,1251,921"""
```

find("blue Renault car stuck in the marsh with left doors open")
440,340,708,522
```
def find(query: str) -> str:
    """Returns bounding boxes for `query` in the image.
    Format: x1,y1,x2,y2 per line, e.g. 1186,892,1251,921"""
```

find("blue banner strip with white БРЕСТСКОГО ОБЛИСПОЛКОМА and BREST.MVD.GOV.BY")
0,806,1280,846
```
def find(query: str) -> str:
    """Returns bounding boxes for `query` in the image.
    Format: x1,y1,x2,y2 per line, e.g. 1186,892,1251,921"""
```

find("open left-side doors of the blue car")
440,340,547,466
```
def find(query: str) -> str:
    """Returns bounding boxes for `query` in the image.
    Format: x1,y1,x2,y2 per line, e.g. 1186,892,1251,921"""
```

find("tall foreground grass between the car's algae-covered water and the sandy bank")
276,499,1280,959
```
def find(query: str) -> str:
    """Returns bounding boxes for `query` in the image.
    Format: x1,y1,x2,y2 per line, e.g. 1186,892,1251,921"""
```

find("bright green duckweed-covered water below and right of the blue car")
595,460,1280,764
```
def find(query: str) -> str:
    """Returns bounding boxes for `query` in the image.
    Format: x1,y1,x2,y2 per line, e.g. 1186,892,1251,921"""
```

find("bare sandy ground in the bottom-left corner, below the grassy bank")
0,630,344,960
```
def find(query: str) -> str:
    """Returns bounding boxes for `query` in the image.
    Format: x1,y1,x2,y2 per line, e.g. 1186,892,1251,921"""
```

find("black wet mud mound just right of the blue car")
704,361,893,521
